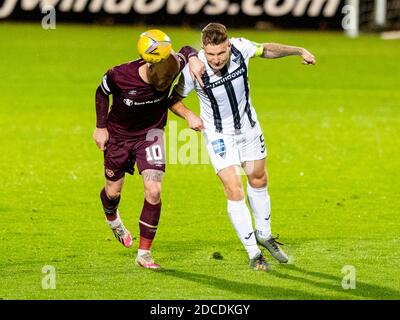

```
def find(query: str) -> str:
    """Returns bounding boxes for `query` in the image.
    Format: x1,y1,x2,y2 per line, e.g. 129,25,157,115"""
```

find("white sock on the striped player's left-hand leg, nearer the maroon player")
228,199,260,259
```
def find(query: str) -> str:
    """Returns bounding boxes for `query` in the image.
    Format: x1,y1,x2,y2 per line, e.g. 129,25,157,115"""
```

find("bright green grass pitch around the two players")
0,23,400,299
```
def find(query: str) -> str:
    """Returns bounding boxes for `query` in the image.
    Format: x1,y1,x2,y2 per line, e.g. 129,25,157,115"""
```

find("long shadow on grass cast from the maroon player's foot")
160,269,333,300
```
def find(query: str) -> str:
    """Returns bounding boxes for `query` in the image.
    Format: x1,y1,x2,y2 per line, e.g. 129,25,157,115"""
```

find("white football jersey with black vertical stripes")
174,38,257,134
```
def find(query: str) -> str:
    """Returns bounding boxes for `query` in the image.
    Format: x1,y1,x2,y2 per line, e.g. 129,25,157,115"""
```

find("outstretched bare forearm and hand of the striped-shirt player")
262,43,316,65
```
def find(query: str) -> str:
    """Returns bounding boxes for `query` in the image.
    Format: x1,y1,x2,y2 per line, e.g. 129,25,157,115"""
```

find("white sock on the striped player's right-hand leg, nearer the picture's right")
247,182,271,238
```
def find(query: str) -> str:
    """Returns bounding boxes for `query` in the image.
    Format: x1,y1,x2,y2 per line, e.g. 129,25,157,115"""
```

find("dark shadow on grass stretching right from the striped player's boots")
269,265,400,299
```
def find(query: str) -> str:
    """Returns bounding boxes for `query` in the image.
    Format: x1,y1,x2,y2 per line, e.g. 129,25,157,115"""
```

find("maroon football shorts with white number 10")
104,131,165,181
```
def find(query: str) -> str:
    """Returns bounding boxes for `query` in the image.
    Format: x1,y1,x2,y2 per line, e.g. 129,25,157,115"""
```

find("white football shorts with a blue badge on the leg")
203,124,267,173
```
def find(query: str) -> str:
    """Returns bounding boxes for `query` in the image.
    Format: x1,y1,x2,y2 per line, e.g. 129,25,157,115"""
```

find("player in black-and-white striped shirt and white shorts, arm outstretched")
170,23,315,271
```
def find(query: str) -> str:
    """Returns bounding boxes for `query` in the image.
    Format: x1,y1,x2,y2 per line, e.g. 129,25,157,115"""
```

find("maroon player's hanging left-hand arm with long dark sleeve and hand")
93,86,109,151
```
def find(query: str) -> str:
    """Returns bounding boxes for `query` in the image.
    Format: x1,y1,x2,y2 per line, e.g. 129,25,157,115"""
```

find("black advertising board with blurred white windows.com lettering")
0,0,344,29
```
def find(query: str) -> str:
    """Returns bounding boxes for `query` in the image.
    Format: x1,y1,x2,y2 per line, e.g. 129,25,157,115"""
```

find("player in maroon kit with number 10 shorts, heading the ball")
93,33,204,269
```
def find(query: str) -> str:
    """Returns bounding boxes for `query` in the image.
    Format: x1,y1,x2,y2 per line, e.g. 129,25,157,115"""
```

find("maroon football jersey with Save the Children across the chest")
101,47,197,138
